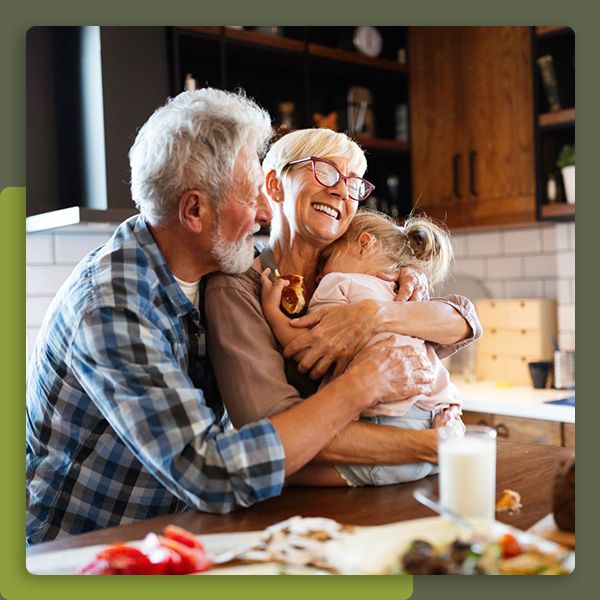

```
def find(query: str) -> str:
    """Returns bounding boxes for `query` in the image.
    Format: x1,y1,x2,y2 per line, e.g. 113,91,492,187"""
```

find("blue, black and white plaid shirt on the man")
26,217,284,543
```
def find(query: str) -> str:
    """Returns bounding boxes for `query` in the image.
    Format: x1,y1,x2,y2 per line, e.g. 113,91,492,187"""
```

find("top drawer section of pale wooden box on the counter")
477,327,553,360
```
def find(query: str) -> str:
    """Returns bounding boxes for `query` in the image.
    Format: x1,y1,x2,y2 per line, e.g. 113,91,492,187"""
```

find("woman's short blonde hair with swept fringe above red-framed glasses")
263,128,367,177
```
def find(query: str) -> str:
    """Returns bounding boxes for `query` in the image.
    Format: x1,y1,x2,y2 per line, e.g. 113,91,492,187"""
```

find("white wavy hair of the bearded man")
129,88,272,225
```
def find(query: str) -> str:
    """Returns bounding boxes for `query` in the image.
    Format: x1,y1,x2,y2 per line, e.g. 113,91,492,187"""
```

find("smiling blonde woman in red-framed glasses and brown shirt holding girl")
205,129,478,482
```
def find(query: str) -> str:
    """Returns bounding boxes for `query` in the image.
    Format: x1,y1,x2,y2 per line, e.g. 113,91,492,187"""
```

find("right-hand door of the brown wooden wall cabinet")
462,27,535,225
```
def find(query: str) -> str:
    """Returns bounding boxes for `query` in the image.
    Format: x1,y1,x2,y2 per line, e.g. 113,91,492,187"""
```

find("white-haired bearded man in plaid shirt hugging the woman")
27,89,434,543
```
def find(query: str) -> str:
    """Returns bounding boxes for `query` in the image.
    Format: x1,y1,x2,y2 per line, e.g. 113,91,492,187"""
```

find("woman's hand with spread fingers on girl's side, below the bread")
284,300,379,379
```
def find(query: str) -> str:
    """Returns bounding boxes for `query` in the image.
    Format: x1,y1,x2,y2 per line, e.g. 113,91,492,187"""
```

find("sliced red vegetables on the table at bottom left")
78,525,213,575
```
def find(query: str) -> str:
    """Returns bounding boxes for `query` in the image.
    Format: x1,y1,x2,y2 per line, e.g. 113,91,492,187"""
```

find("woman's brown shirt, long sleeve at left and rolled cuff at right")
204,267,481,427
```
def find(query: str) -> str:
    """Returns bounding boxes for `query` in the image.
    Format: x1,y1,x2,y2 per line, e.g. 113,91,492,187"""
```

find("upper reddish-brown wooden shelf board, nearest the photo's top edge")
176,26,407,73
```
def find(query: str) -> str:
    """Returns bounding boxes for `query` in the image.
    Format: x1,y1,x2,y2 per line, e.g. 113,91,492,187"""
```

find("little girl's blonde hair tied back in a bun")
335,209,454,288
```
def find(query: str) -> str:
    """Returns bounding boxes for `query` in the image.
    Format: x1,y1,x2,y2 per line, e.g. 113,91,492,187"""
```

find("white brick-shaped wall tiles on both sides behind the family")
26,223,575,349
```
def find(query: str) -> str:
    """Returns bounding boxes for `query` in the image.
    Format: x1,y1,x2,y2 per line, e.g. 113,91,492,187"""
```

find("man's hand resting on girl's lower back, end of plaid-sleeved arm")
347,336,434,405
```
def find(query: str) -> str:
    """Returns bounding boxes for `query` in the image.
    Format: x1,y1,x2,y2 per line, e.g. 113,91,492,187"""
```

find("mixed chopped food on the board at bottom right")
402,533,569,575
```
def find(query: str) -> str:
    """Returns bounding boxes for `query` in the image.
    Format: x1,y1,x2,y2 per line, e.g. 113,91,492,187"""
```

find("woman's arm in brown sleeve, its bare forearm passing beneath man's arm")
205,275,437,464
